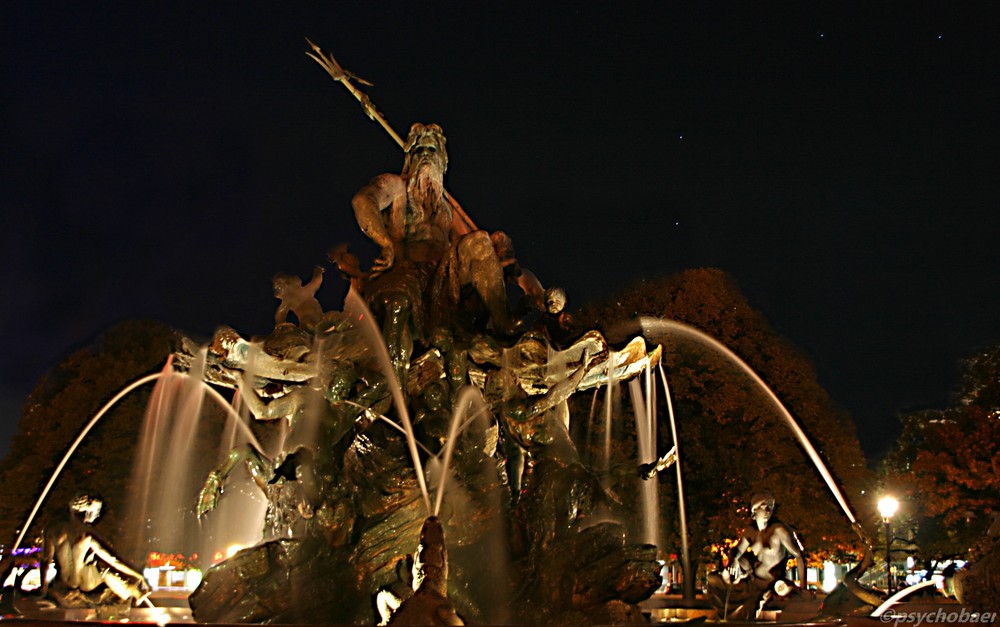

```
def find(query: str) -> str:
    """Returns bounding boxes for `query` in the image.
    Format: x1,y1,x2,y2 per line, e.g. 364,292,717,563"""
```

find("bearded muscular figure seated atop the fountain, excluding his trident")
351,124,518,380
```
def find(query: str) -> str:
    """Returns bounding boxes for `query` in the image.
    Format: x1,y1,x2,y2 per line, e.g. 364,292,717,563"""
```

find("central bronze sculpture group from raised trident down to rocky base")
183,41,669,624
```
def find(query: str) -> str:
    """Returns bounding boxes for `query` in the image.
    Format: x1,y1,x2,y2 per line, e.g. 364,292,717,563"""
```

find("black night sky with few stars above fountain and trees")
0,0,1000,464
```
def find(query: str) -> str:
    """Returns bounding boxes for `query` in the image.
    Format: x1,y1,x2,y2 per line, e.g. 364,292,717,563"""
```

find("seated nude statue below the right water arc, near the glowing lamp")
708,492,806,620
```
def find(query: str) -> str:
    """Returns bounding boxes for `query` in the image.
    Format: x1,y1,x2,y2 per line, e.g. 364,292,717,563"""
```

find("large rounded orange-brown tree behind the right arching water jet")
579,269,868,559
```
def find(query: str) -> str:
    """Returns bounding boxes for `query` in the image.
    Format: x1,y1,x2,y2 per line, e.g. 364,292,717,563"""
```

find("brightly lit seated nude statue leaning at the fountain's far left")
42,496,149,605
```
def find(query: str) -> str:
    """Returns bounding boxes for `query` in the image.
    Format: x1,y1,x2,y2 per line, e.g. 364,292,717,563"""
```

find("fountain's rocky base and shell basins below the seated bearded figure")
164,280,659,623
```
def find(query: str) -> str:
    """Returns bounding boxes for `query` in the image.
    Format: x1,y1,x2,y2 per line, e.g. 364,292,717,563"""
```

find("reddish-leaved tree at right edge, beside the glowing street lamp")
883,345,1000,559
